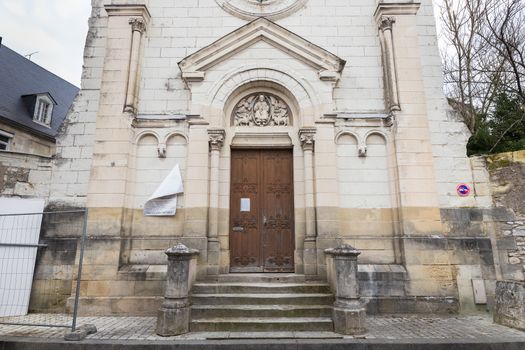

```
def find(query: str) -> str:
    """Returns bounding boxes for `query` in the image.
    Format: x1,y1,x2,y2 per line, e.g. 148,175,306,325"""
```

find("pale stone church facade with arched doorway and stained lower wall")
45,0,499,314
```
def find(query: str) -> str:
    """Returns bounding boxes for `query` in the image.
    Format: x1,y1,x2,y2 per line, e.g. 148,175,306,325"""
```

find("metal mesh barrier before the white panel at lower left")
0,209,87,332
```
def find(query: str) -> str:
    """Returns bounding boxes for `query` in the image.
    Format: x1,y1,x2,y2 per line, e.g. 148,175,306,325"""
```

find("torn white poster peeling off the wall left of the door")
144,164,184,216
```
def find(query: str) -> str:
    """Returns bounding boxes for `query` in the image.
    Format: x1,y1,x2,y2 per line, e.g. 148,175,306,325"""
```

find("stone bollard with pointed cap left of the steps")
157,243,199,337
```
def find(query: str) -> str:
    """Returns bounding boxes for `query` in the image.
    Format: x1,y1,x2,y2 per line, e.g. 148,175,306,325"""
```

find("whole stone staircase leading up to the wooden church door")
190,274,334,332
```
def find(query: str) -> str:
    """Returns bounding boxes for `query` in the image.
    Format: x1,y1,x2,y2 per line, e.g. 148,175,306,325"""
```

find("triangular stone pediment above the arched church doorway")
179,18,346,81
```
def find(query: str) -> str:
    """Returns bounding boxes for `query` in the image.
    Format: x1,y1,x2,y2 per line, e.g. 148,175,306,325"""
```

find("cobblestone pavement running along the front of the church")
0,314,525,341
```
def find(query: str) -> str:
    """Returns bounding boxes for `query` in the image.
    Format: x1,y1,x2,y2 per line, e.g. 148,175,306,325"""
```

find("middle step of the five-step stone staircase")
191,293,334,305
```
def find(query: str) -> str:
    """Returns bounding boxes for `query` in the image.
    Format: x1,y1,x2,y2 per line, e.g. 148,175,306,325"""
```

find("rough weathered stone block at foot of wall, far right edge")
494,281,525,330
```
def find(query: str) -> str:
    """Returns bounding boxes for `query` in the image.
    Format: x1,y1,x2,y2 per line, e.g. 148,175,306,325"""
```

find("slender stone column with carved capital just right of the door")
299,127,317,275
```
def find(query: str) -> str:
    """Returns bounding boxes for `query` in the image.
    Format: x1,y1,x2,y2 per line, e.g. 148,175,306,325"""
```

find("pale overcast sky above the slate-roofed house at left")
0,0,91,86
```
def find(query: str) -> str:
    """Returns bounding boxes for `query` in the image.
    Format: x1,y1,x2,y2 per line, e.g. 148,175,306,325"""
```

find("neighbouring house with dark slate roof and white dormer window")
0,45,79,199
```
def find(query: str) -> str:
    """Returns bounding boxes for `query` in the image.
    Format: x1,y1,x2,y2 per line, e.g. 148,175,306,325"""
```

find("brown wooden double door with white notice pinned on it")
230,149,295,272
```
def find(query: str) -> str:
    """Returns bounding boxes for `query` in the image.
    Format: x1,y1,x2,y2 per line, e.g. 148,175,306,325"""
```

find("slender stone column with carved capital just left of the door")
208,129,226,275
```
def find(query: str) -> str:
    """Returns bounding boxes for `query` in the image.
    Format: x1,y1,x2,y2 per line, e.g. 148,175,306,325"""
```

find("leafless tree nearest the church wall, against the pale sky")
441,0,503,133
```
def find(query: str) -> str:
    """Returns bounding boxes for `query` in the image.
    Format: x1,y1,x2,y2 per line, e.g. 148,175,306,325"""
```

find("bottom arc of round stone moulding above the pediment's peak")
215,0,307,20
